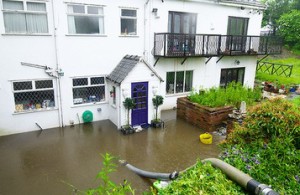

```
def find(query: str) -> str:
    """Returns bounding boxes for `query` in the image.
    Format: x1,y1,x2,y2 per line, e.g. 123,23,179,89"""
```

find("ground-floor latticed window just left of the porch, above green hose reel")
73,77,105,105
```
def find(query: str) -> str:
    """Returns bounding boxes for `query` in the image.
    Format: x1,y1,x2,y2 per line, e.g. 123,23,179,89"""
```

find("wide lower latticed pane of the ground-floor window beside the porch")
73,86,105,104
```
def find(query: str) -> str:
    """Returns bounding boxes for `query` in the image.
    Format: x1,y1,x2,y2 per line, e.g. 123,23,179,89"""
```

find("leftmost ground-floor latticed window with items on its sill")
13,80,55,112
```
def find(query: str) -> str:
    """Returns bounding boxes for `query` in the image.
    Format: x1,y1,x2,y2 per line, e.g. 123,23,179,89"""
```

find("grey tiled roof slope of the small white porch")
106,55,141,84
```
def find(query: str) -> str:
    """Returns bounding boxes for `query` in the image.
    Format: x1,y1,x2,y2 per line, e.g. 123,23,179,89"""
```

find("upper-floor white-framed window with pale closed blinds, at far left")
3,0,48,34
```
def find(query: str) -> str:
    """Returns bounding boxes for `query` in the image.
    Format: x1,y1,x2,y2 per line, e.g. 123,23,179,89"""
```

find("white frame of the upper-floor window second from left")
67,3,105,36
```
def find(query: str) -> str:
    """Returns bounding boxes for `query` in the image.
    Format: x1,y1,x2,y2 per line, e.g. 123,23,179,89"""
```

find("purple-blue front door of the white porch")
131,82,148,126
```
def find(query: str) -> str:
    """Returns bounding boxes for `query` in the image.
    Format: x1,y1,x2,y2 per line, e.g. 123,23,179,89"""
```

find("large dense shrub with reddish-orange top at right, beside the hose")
221,99,300,194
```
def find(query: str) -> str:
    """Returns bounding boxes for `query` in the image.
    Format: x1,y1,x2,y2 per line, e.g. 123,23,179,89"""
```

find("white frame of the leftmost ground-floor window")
11,79,57,113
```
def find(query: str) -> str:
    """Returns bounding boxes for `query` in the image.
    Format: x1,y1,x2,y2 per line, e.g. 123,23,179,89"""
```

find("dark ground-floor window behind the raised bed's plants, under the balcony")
220,68,245,87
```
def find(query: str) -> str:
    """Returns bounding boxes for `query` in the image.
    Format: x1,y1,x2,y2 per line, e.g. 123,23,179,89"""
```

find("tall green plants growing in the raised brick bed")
188,82,261,108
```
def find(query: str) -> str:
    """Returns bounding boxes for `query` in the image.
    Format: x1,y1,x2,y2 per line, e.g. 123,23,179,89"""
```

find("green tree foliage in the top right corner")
277,10,300,49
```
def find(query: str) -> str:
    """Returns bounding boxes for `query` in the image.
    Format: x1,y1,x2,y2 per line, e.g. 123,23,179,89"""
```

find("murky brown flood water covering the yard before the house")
0,111,223,195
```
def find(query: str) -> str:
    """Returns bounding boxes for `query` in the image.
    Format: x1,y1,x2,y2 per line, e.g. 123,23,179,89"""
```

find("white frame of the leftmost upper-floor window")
2,0,49,35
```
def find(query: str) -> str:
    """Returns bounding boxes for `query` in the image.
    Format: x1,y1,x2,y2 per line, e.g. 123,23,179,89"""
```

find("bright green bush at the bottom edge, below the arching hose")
160,161,245,195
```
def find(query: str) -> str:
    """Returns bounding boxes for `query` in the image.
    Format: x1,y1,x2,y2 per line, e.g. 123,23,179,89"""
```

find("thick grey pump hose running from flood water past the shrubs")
119,158,279,195
